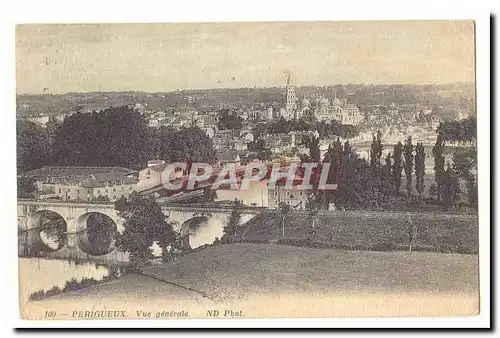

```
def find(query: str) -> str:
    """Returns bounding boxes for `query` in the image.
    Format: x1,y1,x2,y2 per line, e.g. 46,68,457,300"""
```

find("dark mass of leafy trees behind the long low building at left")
17,106,216,173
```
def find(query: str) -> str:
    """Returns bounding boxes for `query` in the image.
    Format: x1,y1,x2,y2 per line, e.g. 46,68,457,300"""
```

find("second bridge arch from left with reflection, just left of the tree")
73,211,118,256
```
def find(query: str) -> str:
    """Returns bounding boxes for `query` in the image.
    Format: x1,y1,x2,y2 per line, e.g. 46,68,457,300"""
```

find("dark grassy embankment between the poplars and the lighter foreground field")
240,211,479,254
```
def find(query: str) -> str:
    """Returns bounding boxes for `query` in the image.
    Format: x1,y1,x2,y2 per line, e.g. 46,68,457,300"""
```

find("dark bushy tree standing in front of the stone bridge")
115,193,175,270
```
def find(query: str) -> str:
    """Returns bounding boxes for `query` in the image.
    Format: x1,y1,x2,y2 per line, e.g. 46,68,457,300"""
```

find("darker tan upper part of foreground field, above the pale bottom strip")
141,243,478,300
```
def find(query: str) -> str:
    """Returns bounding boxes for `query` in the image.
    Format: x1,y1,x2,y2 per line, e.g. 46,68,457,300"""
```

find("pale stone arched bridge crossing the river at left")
17,199,262,263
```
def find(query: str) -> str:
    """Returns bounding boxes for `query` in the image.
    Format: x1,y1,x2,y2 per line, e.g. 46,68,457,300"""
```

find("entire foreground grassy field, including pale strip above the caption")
24,243,478,319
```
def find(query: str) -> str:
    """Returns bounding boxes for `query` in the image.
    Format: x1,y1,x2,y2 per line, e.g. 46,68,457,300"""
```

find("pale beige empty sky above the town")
16,21,474,94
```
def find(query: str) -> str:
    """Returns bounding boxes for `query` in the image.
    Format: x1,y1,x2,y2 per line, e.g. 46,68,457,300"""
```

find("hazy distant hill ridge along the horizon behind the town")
16,83,475,116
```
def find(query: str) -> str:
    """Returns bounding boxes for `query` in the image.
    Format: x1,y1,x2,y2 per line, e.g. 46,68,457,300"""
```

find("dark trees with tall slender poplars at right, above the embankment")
302,121,477,209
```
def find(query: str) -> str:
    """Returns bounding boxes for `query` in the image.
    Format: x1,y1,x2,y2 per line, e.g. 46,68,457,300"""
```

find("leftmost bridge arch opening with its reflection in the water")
21,210,68,252
